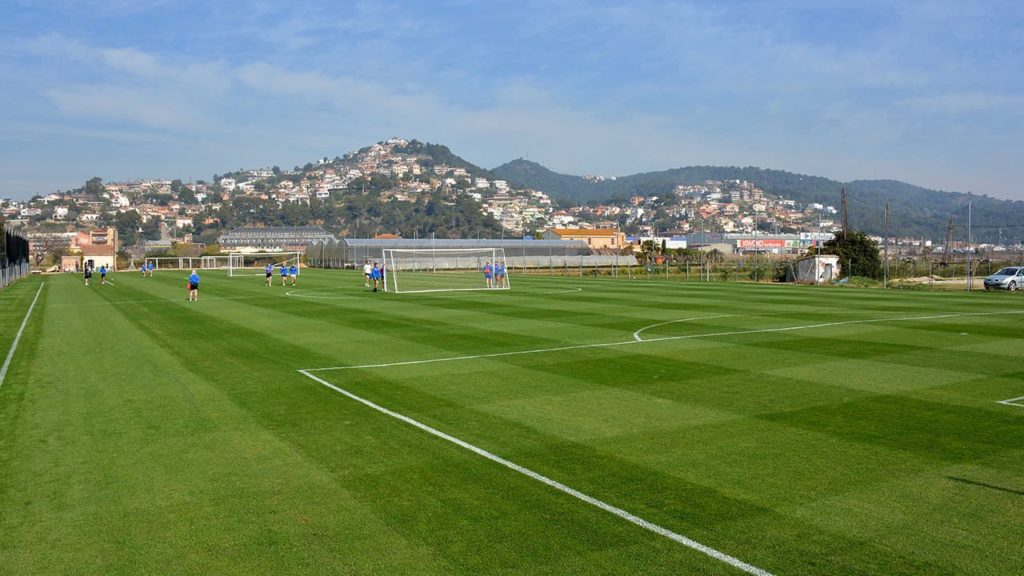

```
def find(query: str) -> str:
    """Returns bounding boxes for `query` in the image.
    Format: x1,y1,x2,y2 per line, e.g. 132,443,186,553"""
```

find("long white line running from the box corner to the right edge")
304,310,1024,372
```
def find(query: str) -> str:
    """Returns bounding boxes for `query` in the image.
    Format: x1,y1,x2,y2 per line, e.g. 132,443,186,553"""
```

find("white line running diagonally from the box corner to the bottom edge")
299,370,772,576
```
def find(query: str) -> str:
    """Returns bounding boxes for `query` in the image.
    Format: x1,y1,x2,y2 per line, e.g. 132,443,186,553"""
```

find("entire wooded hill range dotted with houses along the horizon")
0,138,1024,258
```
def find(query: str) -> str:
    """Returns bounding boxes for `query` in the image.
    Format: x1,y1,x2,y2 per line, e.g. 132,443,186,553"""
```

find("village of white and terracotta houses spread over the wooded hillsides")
0,138,970,261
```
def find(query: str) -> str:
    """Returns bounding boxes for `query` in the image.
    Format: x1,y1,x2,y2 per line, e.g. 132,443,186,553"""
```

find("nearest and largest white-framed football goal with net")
381,248,510,292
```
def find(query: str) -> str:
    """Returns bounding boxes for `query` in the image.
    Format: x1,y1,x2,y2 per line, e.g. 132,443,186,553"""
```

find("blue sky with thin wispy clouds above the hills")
0,0,1024,200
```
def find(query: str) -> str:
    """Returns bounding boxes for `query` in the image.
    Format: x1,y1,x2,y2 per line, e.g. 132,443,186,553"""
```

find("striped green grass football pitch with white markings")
0,271,1024,575
